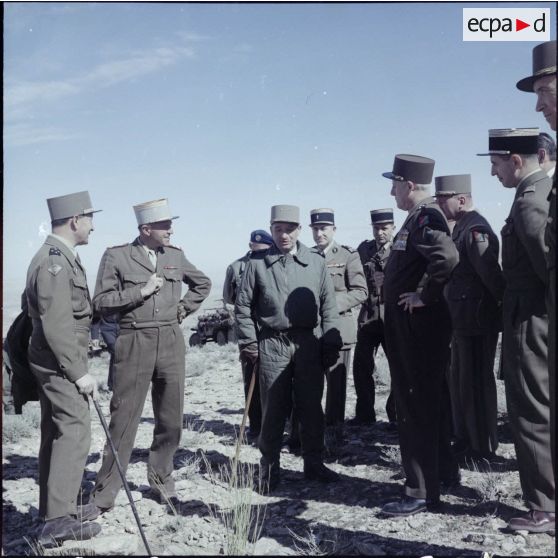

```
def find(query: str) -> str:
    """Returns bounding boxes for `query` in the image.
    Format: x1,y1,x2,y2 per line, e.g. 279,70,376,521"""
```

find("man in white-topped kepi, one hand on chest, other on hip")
92,199,211,511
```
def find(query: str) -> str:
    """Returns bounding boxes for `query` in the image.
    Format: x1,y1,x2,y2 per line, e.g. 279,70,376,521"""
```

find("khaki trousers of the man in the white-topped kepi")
93,325,185,508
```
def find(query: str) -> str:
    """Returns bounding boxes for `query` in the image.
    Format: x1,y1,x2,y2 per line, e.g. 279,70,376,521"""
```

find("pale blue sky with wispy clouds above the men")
4,2,556,302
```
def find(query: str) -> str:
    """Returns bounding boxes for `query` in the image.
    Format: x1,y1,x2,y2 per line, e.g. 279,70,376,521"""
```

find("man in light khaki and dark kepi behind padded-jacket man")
310,208,368,451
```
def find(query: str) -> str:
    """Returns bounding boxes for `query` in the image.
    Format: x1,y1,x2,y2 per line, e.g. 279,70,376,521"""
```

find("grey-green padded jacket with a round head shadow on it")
235,242,340,347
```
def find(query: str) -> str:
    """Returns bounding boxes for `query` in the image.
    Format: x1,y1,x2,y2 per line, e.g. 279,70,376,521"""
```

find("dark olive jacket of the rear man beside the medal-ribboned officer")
357,240,391,325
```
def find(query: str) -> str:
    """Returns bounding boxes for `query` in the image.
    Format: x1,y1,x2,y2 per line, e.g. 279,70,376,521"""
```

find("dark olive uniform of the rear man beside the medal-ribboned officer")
353,240,397,422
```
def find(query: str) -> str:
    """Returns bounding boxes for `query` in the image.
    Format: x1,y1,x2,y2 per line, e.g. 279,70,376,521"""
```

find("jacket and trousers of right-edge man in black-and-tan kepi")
502,171,554,512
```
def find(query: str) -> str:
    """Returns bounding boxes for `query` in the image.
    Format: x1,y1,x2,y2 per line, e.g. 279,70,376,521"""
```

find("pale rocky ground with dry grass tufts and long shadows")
2,304,555,556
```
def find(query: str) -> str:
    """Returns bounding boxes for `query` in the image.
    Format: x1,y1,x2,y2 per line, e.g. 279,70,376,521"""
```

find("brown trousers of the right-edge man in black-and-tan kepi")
502,300,555,512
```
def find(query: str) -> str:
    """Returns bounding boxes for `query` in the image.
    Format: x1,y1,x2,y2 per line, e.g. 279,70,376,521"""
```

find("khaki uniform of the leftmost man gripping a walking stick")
25,235,92,520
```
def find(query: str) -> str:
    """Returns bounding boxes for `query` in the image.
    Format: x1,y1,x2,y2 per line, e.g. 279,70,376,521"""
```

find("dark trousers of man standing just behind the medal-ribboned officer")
448,332,498,456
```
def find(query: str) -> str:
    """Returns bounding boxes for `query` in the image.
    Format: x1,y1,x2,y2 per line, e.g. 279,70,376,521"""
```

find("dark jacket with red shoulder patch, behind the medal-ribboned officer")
446,210,504,335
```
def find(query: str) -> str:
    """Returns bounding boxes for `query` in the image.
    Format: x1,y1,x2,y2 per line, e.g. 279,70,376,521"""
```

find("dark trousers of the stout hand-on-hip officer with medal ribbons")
385,303,458,500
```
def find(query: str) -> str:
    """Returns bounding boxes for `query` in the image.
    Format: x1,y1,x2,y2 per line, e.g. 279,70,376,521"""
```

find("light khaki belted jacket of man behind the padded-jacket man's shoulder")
322,241,368,345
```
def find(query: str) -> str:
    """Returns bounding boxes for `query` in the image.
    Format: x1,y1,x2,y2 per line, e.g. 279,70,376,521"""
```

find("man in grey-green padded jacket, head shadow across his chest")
235,205,342,492
